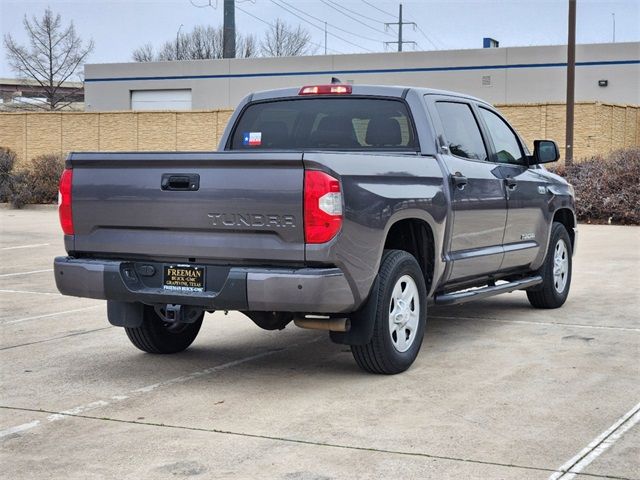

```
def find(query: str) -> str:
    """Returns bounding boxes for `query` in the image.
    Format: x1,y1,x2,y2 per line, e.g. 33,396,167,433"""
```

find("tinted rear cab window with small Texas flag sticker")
231,97,418,151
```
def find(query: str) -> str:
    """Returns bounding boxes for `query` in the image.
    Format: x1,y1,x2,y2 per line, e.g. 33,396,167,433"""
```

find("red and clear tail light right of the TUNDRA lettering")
304,170,342,243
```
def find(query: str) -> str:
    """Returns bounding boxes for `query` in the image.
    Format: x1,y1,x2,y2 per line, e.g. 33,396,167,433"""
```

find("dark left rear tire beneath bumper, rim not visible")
125,305,204,353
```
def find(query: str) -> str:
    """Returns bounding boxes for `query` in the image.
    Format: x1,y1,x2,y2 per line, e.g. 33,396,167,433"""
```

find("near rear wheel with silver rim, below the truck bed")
351,250,427,375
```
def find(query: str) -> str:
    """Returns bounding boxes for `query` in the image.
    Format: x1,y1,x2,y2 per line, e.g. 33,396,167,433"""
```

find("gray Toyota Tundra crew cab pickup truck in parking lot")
54,84,577,374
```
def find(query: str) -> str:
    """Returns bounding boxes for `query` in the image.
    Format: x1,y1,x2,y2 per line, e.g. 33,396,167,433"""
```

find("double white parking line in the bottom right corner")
548,403,640,480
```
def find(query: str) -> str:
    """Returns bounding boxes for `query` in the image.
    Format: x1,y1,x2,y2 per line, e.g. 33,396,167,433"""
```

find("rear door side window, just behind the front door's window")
436,102,487,161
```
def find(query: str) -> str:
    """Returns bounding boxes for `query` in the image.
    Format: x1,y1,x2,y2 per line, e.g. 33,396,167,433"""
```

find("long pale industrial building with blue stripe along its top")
85,42,640,111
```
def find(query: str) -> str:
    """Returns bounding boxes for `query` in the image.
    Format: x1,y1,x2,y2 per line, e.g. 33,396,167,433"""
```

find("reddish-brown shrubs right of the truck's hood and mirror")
552,148,640,225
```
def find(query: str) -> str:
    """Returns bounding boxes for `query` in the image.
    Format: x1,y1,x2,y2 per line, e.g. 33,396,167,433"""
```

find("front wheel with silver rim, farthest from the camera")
527,222,573,308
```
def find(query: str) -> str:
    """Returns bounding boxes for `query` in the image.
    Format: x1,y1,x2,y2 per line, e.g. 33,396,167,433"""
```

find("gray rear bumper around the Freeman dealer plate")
54,257,355,313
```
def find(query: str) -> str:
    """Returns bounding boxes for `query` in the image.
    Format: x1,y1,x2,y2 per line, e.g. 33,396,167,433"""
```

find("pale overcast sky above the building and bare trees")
0,0,640,77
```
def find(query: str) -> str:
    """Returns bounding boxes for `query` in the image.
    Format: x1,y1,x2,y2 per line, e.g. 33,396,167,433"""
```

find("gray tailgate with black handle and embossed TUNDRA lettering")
67,152,304,264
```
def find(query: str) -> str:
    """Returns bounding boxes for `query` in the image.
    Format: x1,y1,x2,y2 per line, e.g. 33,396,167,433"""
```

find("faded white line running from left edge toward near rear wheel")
0,337,322,439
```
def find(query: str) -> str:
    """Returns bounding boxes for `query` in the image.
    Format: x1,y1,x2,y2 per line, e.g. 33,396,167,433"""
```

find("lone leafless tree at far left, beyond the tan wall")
4,8,94,110
